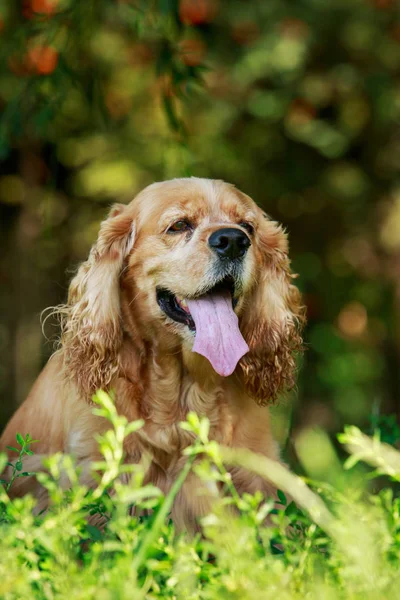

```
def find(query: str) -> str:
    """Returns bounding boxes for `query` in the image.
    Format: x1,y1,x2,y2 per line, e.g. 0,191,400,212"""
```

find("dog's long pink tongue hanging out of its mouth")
187,293,249,377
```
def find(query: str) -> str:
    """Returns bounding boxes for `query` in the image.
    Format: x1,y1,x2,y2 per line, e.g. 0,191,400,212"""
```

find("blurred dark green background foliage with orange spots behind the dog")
0,0,400,454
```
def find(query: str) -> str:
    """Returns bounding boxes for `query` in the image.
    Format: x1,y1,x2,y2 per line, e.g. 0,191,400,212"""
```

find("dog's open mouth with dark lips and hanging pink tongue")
156,277,249,376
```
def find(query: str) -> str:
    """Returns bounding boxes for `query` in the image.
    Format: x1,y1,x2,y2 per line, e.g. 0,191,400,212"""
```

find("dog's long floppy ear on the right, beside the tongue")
240,215,305,406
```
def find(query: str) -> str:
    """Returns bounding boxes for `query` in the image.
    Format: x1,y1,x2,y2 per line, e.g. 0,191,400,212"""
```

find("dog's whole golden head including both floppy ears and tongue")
62,178,303,404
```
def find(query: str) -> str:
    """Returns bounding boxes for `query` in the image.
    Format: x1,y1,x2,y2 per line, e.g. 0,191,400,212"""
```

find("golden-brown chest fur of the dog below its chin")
112,355,270,476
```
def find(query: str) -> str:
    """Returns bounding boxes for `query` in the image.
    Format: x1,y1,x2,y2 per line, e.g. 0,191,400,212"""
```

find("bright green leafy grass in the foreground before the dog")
0,392,400,600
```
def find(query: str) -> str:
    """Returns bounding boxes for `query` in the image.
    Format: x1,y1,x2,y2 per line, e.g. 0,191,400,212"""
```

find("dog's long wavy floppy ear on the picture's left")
60,205,135,399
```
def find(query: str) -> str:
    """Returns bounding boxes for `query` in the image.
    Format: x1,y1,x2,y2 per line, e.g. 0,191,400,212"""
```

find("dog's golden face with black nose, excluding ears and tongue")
124,179,260,352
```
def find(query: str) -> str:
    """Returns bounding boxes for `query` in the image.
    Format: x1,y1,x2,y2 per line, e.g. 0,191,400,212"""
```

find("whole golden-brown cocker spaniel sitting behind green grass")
0,178,303,529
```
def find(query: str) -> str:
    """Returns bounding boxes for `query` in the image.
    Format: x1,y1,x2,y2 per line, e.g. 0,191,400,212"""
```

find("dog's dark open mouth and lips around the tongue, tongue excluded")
156,277,238,331
